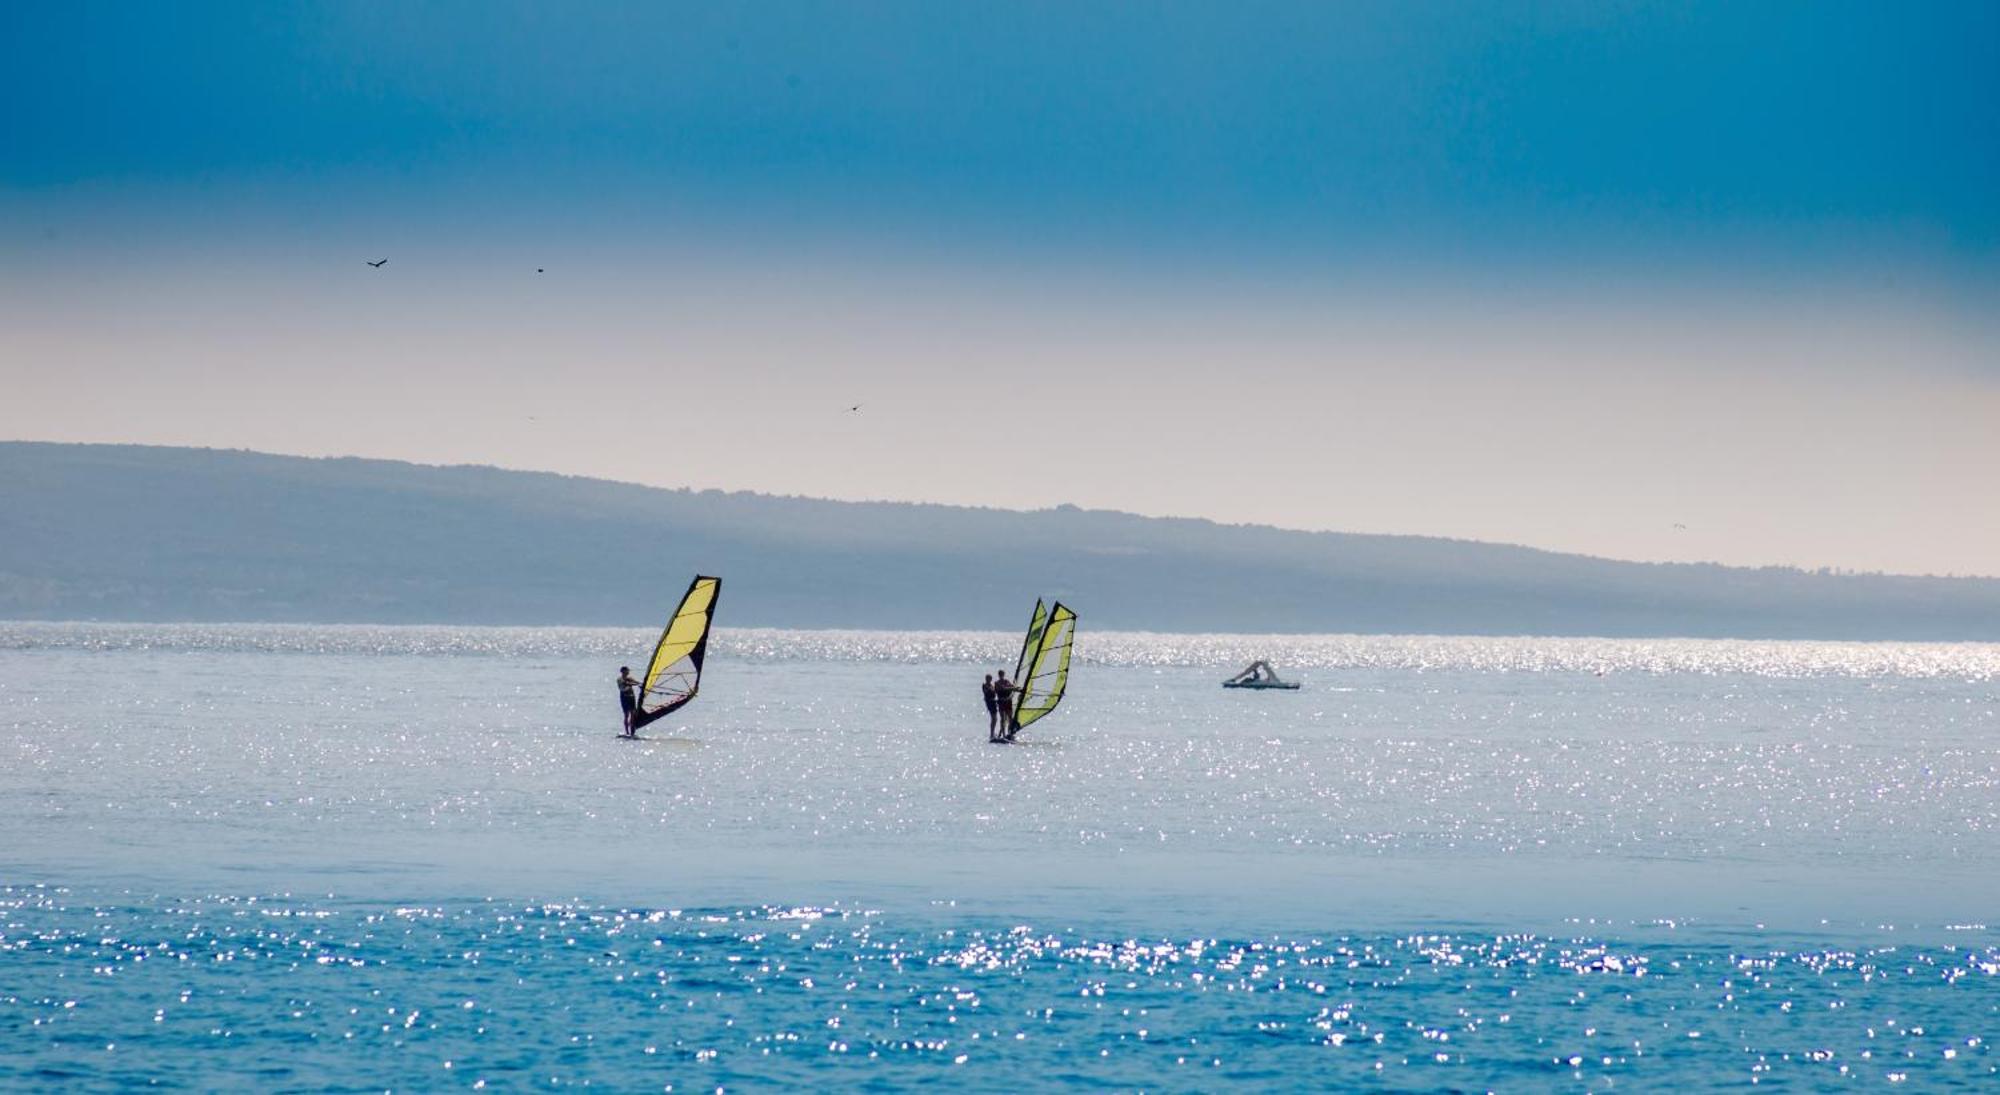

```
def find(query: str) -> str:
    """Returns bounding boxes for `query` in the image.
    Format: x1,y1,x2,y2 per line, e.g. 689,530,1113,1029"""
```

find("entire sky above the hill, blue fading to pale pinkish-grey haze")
0,0,2000,575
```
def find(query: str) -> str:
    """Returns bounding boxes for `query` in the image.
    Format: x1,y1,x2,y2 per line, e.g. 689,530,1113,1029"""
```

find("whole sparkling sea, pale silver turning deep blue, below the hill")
0,617,2000,1091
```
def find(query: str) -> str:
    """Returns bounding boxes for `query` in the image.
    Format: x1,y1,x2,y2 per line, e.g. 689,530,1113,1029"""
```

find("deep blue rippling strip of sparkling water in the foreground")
0,887,2000,1089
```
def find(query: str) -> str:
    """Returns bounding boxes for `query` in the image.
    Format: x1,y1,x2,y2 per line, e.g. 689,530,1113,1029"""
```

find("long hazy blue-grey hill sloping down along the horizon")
0,442,2000,639
